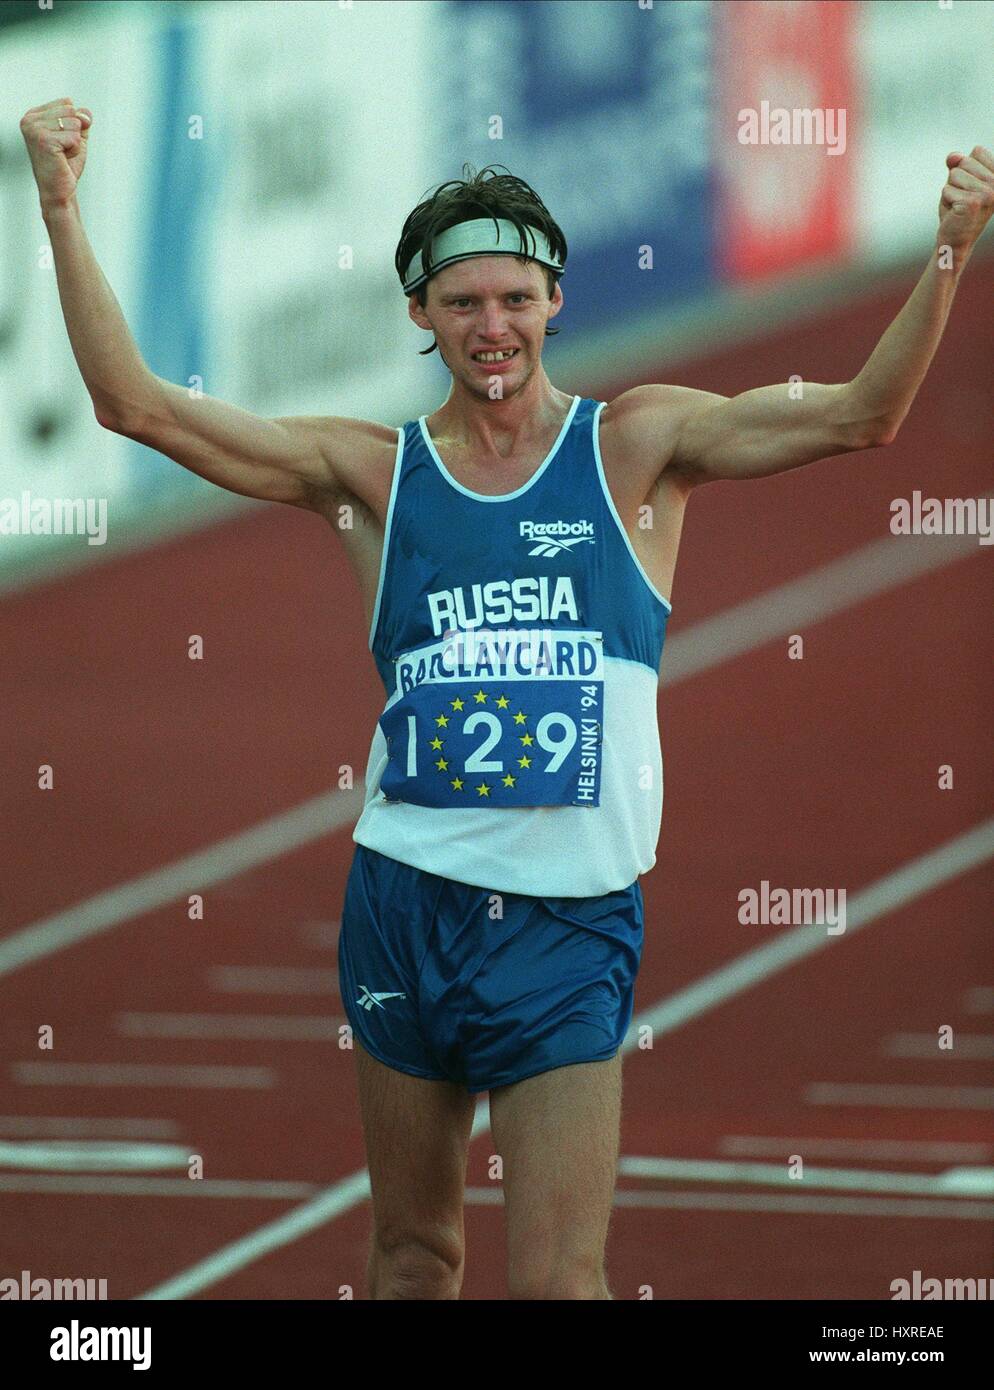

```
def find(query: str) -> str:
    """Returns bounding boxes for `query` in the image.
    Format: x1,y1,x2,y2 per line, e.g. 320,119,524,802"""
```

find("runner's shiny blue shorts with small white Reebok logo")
338,845,642,1093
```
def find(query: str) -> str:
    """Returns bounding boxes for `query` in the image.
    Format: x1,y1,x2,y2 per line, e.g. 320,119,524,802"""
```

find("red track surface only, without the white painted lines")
0,261,994,1300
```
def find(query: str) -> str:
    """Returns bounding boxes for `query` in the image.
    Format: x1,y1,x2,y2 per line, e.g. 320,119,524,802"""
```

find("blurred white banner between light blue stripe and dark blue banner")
197,4,442,423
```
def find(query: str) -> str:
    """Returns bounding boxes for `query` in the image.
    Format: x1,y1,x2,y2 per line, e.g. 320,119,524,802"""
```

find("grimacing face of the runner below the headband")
409,256,563,399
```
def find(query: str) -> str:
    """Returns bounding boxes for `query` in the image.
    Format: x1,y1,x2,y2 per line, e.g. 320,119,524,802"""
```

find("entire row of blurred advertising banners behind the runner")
0,0,994,587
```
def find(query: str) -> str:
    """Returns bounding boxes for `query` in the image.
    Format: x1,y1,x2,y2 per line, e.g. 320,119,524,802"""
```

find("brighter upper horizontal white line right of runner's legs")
617,1154,994,1198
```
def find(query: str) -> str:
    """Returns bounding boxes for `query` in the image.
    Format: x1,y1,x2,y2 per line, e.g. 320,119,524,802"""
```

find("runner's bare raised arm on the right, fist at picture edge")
636,146,994,482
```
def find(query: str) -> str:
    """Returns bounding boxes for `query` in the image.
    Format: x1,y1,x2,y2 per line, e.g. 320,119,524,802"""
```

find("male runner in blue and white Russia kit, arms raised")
21,99,994,1300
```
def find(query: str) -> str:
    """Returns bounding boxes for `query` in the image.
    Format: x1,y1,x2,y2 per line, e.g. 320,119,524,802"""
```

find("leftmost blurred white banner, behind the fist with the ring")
0,14,167,542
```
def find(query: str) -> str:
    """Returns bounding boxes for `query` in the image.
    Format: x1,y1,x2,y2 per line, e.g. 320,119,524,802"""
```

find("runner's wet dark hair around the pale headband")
393,164,567,357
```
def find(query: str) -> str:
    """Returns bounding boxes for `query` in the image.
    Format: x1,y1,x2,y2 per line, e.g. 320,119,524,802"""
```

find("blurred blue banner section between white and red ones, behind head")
435,0,715,334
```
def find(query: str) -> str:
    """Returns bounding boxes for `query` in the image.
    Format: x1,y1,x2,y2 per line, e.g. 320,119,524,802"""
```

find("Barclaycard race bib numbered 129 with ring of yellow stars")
380,628,603,808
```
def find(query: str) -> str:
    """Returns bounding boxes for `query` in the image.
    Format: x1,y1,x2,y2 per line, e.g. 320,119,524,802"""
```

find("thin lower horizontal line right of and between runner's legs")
461,1187,994,1217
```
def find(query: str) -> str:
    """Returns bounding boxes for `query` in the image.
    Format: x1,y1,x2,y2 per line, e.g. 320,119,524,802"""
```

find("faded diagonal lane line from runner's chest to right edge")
660,519,987,685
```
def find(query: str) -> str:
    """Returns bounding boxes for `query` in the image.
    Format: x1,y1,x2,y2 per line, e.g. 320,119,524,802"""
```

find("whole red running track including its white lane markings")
0,260,994,1300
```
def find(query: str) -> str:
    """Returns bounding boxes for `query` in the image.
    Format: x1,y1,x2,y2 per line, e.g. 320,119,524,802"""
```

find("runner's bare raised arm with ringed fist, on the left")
21,99,383,507
